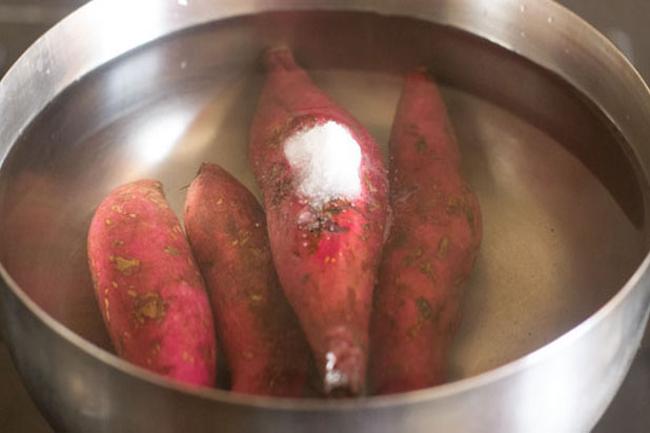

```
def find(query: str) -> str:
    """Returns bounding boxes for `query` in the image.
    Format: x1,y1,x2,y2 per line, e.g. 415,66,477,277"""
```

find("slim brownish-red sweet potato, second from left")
185,164,310,397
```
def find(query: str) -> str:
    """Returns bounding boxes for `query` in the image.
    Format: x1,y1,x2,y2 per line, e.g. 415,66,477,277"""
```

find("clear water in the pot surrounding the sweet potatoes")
0,13,647,378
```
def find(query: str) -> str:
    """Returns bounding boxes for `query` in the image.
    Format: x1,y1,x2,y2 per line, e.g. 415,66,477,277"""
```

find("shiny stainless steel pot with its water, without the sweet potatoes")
0,0,650,432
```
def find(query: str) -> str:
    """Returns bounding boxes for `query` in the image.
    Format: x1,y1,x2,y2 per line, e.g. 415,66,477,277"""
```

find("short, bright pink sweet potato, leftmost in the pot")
88,180,216,386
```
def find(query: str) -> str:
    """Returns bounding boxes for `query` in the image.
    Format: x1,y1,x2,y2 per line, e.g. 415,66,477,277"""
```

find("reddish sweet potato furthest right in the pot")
370,72,481,394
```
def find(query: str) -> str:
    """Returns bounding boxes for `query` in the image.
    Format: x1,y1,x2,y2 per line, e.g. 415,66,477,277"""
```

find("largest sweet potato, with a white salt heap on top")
249,48,388,396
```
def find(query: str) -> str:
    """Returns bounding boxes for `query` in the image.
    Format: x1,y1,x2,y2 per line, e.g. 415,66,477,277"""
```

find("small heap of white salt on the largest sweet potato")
284,121,361,208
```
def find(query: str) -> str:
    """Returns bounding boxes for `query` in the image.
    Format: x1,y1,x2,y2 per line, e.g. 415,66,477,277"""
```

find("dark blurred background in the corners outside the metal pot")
0,0,650,433
